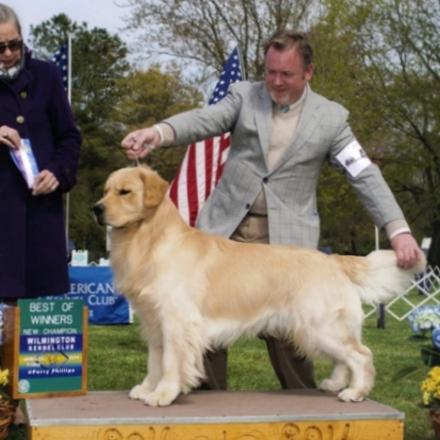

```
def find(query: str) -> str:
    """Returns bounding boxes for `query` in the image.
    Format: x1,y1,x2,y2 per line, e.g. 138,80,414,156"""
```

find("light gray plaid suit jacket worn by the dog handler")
164,82,404,248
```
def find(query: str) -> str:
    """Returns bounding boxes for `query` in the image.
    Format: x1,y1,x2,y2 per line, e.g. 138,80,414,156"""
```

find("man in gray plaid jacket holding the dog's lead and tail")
121,30,422,389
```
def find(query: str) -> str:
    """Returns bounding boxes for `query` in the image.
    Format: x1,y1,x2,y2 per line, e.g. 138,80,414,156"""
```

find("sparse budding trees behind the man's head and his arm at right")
120,0,440,258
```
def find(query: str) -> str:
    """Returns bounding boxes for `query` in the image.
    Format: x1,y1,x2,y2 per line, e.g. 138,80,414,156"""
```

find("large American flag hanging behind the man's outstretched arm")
169,47,243,226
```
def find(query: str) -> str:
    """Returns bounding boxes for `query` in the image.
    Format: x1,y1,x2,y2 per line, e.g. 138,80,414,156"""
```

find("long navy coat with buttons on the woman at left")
0,52,81,298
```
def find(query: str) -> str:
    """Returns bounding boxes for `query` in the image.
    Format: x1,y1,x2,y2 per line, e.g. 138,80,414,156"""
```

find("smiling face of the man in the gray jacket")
265,47,313,105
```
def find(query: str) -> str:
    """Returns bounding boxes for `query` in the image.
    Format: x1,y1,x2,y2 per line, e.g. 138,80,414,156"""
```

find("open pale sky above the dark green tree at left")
8,0,130,43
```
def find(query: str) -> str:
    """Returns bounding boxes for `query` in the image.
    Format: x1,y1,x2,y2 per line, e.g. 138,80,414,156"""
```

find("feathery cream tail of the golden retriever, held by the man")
339,250,426,305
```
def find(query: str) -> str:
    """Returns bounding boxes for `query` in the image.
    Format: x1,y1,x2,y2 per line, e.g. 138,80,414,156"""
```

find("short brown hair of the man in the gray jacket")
264,29,313,68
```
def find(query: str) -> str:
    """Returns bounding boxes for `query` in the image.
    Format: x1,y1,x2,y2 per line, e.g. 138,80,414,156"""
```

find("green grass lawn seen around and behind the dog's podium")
9,295,434,440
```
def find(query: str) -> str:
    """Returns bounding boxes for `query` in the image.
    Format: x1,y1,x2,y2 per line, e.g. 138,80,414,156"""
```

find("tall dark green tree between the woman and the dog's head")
30,14,129,259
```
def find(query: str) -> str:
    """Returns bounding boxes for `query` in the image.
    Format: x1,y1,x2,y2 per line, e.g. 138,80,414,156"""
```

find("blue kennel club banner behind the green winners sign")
45,266,133,324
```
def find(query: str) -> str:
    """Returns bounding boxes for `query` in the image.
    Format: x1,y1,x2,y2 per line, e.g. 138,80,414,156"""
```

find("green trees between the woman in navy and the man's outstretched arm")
31,14,202,261
